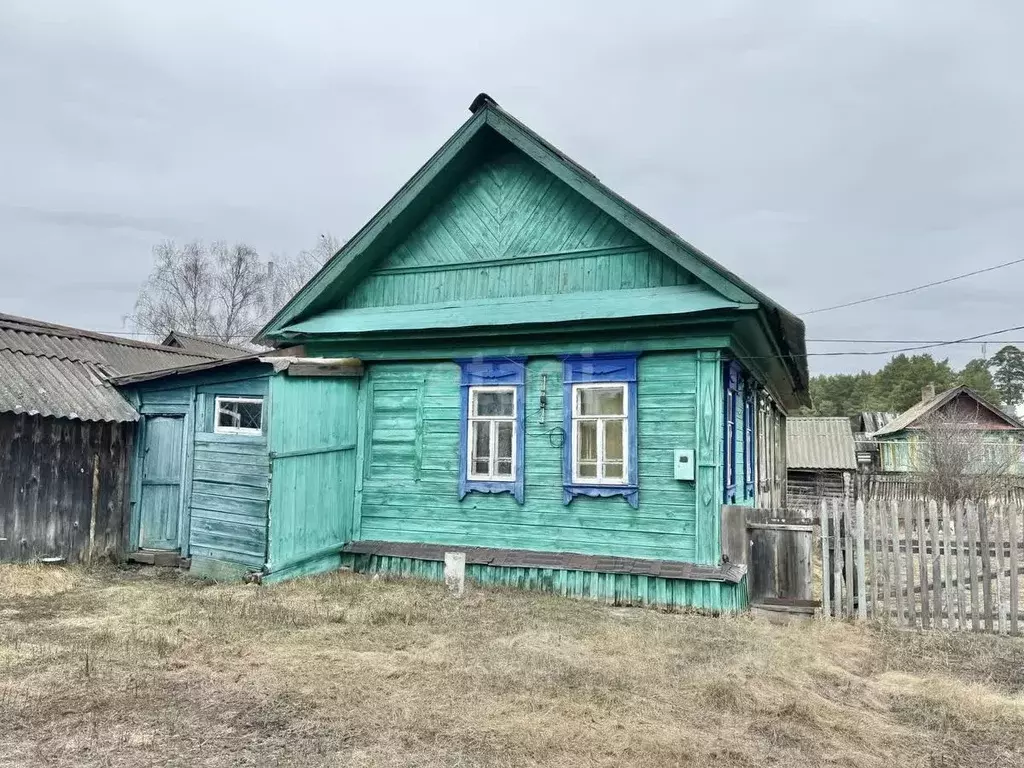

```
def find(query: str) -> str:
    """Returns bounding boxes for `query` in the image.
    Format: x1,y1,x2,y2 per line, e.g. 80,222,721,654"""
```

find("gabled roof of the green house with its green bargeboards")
257,93,809,404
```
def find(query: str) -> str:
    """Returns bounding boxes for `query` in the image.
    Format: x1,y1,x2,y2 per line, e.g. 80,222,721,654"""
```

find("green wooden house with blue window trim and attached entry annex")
122,94,808,610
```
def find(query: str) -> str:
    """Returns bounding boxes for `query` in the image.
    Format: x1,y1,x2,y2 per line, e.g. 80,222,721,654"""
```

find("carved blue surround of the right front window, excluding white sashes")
561,352,640,509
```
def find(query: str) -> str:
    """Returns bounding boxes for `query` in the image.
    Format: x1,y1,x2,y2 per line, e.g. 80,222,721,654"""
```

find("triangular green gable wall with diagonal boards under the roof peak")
341,145,695,308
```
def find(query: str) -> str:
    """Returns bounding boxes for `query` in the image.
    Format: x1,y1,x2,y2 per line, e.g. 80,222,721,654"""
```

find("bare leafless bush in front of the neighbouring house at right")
916,403,1021,503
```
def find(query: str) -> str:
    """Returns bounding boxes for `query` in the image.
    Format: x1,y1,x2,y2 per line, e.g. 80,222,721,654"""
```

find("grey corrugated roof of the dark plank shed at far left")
0,313,216,421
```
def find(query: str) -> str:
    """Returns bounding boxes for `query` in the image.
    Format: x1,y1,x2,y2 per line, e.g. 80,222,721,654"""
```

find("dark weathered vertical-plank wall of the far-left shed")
0,413,135,562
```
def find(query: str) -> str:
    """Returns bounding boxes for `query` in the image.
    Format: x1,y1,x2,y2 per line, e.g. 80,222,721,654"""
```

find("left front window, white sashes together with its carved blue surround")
456,357,526,504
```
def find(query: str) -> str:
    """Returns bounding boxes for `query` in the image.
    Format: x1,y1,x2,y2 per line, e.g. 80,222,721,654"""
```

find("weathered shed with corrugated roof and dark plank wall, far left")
0,314,220,561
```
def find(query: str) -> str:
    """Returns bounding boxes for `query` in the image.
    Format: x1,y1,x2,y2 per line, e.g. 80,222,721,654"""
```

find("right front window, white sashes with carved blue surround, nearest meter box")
562,353,640,509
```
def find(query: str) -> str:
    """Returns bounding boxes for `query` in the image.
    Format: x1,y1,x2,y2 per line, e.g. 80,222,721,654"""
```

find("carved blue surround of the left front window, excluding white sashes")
456,357,526,504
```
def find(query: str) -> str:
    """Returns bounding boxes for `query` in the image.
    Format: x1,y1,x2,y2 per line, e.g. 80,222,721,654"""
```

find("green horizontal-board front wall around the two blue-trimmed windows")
358,352,704,562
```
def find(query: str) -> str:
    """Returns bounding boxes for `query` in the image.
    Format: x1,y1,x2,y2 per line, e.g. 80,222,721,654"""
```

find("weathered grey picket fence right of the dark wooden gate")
820,498,1024,635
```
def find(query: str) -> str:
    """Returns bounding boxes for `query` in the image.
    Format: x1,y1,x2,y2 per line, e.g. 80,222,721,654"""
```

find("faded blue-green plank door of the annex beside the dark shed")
138,416,185,550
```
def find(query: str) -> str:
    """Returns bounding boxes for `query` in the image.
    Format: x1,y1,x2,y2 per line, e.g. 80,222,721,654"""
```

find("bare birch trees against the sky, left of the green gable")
128,234,339,343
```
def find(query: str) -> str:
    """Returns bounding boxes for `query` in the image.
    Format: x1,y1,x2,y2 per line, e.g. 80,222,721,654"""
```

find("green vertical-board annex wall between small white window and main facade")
267,376,359,578
